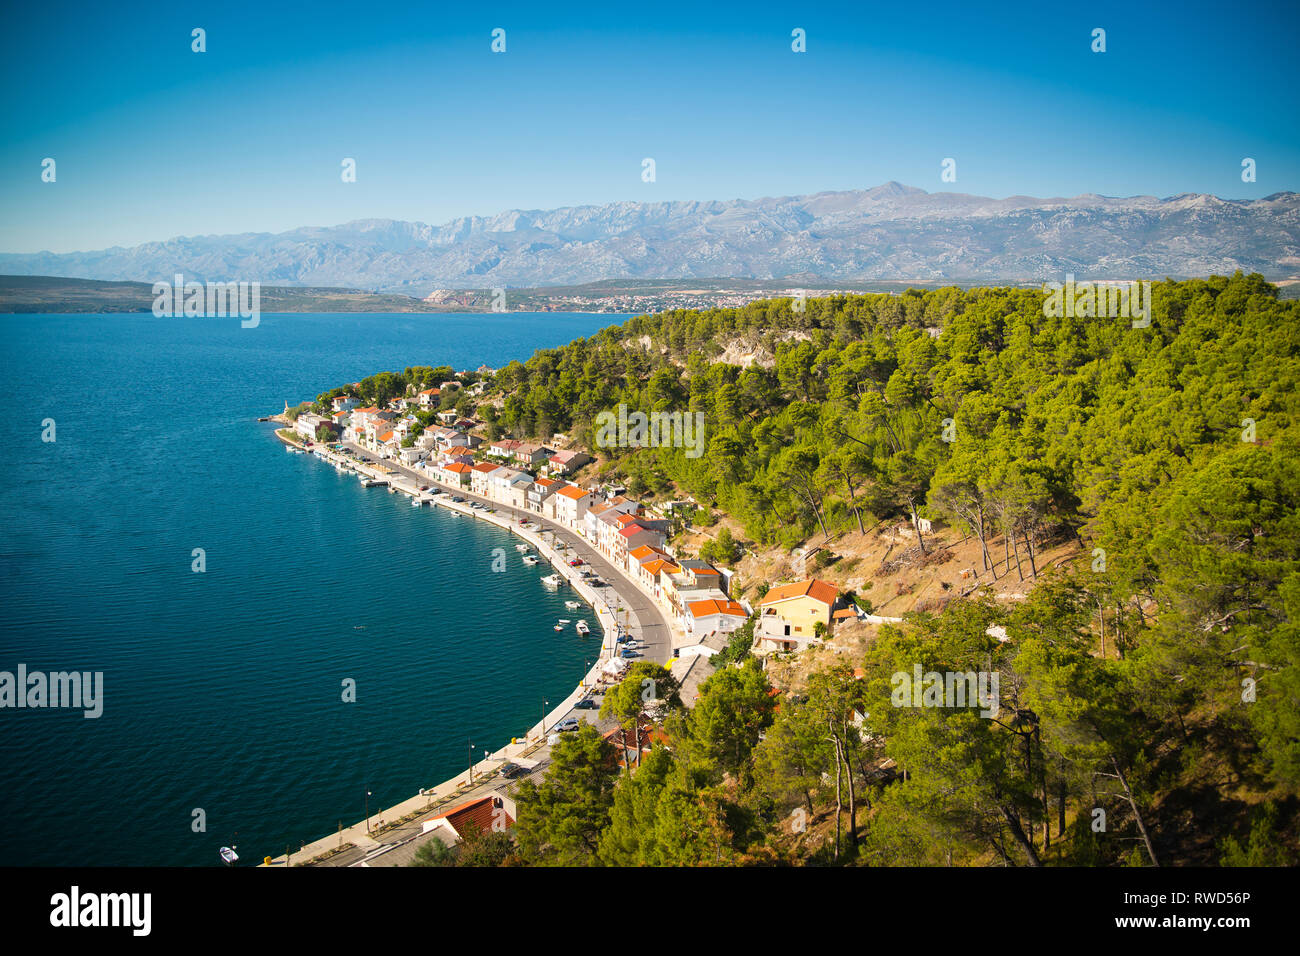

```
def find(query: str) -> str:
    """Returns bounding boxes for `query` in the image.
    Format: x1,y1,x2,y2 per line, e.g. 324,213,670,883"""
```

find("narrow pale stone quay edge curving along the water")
257,426,672,866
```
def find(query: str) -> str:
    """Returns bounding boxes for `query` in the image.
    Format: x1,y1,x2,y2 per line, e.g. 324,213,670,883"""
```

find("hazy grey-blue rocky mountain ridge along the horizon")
0,182,1300,295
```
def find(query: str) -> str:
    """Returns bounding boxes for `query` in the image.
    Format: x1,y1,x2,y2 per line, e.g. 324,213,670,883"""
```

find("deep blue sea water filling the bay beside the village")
0,313,623,865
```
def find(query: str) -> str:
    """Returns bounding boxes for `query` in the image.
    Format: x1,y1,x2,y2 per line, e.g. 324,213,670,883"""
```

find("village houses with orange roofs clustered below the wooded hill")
286,369,880,662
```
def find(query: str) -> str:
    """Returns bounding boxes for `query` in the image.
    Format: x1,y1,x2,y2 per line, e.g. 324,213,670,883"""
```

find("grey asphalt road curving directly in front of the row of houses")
343,442,672,663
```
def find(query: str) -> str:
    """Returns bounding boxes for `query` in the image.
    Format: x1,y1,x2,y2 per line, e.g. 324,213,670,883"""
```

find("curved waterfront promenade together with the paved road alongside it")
264,433,673,866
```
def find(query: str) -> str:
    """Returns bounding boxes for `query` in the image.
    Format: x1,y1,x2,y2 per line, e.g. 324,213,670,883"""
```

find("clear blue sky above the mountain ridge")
0,0,1300,252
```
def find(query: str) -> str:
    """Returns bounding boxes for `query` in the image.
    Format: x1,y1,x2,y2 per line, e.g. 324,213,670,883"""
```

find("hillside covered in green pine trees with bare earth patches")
488,274,1300,866
